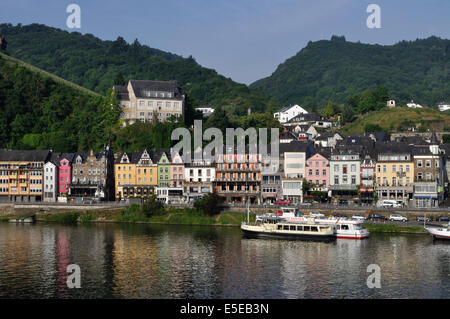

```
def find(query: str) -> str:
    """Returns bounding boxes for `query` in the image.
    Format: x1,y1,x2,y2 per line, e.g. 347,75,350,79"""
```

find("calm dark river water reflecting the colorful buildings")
0,223,450,298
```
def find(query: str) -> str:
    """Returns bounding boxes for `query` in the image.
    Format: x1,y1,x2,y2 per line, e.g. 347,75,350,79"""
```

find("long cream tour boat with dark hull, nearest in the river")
241,216,336,240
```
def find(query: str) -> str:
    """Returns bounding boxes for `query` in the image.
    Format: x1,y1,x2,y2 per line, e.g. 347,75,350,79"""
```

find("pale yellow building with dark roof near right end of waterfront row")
375,143,414,205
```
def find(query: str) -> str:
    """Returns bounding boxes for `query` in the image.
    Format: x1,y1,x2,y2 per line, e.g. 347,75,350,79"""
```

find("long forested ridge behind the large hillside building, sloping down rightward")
0,24,279,114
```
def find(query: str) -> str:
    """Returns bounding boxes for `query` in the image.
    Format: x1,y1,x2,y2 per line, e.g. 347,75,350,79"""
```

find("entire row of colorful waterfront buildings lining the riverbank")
0,134,450,207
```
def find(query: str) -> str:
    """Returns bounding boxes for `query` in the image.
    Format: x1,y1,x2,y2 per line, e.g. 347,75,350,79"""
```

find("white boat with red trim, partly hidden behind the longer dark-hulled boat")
277,207,370,239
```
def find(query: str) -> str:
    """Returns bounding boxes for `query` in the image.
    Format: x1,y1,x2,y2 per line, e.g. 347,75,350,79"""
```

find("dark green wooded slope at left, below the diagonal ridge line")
0,53,120,152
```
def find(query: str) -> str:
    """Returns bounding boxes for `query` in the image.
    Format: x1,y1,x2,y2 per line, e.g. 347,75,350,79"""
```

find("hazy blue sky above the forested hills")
0,0,450,84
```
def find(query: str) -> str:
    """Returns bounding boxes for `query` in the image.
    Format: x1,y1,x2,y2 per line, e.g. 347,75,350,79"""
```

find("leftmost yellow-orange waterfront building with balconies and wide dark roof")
0,150,51,202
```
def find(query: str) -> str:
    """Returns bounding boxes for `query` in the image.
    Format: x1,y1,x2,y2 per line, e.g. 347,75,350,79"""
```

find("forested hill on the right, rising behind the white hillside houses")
250,36,450,108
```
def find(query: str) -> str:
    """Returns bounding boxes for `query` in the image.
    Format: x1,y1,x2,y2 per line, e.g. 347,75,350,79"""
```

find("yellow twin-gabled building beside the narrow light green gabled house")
114,150,158,198
